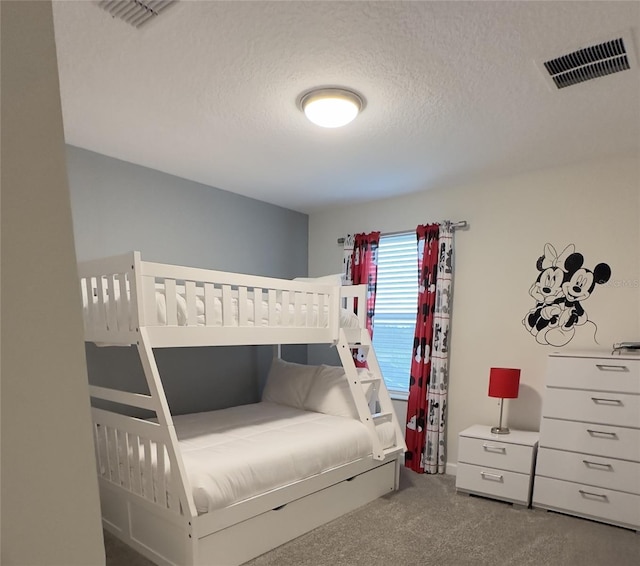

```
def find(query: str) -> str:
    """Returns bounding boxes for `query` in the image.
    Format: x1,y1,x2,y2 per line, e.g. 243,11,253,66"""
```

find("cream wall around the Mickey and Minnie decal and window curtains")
309,156,640,474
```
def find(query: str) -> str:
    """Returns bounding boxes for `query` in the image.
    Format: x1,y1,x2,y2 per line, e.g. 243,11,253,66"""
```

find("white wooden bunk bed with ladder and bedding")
79,252,406,566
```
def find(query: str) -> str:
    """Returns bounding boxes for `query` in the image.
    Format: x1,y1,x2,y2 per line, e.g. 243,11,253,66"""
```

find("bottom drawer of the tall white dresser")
533,477,640,529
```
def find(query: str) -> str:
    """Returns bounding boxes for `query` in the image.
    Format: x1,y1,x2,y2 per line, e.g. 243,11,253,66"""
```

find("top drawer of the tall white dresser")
547,356,640,394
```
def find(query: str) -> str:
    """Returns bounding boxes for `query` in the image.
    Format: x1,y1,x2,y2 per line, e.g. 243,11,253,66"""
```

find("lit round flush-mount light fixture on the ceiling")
300,88,364,128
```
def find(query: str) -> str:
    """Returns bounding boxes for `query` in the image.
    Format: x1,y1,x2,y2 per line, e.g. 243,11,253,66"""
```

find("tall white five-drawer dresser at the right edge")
533,352,640,530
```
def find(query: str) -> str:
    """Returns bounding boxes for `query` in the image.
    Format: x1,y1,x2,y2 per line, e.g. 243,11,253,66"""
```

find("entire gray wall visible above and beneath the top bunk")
67,146,308,414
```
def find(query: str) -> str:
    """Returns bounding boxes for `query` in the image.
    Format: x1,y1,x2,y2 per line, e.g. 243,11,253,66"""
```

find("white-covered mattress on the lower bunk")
174,402,394,514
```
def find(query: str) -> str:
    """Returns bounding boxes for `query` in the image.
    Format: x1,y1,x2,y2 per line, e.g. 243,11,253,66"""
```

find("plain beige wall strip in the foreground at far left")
1,1,105,566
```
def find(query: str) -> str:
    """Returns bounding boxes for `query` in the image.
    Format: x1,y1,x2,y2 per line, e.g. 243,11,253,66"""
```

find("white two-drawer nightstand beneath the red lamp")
456,425,539,507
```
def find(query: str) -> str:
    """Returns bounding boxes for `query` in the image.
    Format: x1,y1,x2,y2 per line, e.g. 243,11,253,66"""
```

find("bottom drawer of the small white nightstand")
456,464,530,505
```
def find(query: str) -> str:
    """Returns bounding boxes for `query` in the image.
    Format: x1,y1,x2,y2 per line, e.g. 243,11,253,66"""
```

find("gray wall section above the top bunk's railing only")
67,146,308,278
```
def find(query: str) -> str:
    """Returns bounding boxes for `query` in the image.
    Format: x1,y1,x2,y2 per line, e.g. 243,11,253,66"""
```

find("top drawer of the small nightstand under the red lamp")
458,436,534,474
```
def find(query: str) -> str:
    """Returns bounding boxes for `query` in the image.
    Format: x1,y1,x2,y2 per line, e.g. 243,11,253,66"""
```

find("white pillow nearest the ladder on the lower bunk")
304,365,373,419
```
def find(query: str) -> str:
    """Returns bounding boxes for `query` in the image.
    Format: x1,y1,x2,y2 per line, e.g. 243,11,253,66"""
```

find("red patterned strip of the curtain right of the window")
405,224,439,473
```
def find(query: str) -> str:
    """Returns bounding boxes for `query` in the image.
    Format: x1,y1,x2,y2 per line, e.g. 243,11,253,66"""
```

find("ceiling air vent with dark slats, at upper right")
542,36,633,89
